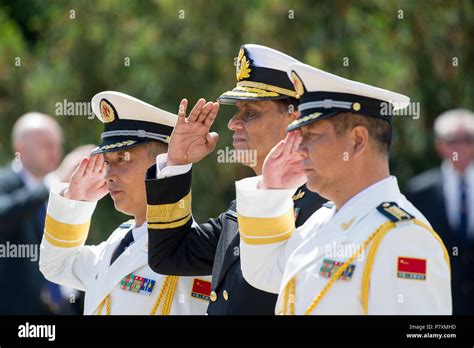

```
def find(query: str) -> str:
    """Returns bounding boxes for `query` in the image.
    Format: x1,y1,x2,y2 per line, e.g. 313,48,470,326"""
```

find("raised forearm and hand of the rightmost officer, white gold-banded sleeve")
236,132,306,293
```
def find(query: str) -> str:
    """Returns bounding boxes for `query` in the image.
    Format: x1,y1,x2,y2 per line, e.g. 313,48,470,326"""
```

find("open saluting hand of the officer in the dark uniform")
166,98,219,166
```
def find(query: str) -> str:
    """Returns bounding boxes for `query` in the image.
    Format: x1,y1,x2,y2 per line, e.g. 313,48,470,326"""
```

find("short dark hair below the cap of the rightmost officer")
327,112,392,155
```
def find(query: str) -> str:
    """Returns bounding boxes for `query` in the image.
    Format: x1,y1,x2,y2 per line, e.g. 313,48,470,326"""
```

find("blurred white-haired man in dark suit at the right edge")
407,109,474,314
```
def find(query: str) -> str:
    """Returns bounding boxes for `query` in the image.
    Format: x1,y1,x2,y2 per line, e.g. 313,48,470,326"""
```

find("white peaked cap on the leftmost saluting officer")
91,91,178,154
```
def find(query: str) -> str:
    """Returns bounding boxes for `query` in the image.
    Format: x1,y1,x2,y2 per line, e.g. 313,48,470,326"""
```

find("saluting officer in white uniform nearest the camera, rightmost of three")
236,64,452,315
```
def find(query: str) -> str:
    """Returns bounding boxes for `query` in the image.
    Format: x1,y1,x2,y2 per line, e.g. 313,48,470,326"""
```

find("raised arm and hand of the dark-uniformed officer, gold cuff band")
146,99,224,275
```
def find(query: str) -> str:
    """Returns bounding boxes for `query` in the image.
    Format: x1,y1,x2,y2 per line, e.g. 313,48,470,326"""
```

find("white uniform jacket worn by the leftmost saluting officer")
40,184,211,315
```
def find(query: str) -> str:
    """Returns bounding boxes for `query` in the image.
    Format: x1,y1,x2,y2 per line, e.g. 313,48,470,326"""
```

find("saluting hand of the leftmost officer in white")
64,154,108,202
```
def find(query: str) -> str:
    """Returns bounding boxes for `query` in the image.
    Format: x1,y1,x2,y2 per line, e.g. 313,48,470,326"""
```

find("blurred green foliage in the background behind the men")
0,0,474,242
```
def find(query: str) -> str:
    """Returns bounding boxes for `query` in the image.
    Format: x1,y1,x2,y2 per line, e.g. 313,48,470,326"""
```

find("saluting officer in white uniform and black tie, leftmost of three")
40,92,211,315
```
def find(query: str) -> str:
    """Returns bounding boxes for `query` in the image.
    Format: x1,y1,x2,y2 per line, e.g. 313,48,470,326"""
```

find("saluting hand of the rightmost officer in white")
260,131,306,189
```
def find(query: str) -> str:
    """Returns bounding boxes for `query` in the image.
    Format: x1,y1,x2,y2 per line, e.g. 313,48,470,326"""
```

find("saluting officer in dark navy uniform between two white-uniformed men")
146,45,324,315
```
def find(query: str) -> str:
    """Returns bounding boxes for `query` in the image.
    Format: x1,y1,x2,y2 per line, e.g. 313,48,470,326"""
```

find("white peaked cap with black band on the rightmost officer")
287,63,410,132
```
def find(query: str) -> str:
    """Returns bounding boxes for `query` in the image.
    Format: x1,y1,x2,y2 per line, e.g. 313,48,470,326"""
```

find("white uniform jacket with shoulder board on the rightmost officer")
236,176,452,314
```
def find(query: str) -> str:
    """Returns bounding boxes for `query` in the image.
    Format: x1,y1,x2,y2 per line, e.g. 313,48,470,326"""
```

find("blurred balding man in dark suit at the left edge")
0,112,93,314
